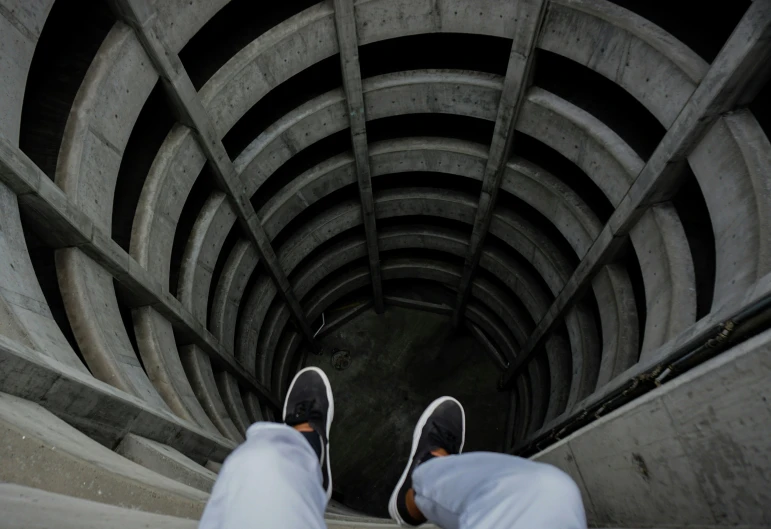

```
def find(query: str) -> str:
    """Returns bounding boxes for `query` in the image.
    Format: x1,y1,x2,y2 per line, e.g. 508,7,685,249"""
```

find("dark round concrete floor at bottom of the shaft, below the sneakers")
306,307,508,516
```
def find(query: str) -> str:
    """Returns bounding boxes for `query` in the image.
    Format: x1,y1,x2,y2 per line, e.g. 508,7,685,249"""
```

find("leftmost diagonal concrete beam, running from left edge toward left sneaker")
0,137,279,409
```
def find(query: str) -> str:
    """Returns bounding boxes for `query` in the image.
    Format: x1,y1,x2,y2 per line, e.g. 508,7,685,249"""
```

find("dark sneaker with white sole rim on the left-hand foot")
284,367,335,500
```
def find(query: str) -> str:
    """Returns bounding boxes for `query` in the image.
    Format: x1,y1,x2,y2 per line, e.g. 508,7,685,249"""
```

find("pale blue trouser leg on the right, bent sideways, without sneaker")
412,452,586,529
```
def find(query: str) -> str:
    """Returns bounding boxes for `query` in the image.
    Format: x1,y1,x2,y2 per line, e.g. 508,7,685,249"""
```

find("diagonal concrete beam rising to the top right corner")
501,0,771,388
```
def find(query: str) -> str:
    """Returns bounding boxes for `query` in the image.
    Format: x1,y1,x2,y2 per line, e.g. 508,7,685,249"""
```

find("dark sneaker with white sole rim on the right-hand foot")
388,397,466,526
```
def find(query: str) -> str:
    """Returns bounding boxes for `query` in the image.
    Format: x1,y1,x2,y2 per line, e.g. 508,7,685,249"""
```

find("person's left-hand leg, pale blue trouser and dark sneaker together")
199,368,334,529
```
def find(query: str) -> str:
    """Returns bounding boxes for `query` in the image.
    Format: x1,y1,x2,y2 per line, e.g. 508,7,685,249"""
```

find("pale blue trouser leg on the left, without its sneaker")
198,422,327,529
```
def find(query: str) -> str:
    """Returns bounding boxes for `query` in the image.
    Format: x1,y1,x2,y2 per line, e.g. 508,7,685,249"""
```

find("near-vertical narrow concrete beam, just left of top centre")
334,0,385,314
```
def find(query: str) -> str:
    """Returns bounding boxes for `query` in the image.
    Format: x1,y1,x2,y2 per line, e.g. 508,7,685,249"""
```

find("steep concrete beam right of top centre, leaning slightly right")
452,0,547,328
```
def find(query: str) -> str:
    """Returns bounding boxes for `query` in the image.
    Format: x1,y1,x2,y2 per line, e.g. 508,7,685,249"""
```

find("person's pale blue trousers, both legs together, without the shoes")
199,423,586,529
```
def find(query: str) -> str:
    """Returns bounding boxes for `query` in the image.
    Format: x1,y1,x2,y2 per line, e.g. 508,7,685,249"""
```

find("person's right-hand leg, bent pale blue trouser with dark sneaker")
389,397,586,529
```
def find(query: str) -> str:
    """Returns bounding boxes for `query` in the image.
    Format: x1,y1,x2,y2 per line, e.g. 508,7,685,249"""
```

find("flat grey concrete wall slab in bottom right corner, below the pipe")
534,324,771,527
